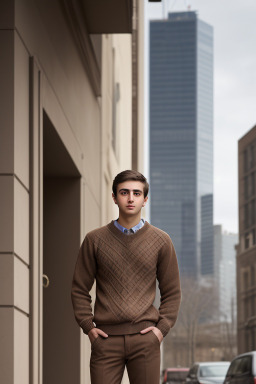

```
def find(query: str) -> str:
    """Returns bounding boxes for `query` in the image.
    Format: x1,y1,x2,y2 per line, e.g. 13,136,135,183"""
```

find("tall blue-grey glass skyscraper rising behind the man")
150,11,214,276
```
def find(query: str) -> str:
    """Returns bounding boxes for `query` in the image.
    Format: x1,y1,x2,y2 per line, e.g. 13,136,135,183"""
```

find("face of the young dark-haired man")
112,181,148,216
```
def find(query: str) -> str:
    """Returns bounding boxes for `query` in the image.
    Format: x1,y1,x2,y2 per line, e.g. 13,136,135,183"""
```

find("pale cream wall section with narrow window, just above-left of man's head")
102,35,132,224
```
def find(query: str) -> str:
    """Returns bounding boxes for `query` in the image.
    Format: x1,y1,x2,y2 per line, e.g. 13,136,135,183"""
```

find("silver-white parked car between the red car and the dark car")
186,361,230,384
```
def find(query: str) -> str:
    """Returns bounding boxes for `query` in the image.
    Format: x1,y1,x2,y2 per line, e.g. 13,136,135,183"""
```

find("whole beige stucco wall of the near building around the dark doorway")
0,0,136,384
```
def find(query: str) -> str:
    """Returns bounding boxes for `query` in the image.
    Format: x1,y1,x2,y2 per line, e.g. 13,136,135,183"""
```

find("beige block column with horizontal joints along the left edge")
0,12,29,384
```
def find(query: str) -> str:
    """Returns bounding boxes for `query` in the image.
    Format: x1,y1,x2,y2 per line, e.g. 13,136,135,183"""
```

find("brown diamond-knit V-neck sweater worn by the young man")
71,221,181,336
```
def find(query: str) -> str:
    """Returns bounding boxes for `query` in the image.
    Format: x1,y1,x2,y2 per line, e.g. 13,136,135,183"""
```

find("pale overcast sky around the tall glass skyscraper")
145,0,256,233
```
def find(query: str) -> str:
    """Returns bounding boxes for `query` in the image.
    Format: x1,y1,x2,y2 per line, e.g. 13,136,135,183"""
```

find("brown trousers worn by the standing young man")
90,331,160,384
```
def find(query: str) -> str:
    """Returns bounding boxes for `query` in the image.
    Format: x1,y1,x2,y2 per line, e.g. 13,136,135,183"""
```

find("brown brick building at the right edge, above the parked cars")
237,126,256,353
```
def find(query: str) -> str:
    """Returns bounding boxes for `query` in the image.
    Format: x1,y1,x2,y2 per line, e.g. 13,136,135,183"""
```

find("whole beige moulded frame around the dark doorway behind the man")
29,56,86,384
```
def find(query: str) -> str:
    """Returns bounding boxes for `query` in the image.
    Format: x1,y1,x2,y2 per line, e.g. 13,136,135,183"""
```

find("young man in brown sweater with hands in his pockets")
71,170,181,384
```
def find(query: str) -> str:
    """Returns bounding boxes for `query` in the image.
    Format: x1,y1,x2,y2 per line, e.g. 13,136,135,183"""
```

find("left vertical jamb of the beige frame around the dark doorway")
29,57,43,384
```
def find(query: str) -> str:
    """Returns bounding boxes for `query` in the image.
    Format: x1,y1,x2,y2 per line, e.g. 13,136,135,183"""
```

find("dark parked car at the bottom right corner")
224,351,256,384
